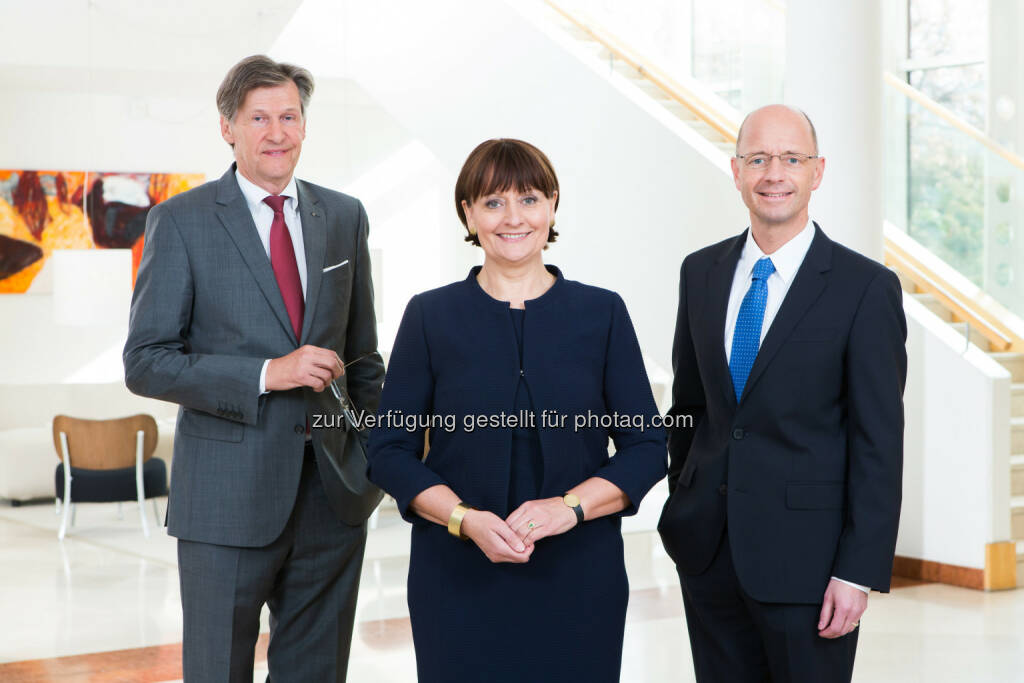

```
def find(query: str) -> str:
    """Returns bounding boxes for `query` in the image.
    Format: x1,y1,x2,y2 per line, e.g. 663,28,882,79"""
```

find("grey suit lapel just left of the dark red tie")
216,164,297,343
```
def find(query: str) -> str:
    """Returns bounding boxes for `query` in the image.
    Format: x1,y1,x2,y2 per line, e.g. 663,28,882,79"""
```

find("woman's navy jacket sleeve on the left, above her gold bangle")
367,296,447,523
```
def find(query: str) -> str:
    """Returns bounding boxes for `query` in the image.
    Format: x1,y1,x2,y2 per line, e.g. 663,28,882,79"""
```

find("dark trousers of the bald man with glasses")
679,531,858,683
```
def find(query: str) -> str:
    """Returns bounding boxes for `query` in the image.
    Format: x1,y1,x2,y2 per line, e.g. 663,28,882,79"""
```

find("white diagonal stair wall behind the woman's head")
273,0,746,368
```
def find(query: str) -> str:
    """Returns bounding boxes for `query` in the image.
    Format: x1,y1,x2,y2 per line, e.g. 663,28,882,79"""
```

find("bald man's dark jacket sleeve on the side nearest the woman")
668,261,707,496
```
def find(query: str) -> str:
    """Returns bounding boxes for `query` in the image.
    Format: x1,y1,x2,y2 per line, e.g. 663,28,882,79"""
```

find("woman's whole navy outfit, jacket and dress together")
369,268,666,683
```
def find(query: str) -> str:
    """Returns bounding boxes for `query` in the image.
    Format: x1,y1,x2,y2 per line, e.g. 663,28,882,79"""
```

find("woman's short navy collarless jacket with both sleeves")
368,266,667,521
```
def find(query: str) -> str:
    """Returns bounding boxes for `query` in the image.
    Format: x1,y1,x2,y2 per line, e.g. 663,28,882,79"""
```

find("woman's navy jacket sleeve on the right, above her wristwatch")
595,294,666,515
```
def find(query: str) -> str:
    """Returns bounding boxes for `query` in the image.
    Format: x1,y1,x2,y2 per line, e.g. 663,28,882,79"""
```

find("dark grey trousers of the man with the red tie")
178,446,367,683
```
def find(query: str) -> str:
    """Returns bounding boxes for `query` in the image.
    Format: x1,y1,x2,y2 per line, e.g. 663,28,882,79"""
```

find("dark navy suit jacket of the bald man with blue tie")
658,224,906,604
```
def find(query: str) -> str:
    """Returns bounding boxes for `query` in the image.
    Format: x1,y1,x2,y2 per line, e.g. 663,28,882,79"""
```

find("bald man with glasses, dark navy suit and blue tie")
658,105,906,683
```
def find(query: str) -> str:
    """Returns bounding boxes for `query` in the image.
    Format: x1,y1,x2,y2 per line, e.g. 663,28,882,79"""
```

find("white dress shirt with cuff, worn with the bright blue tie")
725,220,870,593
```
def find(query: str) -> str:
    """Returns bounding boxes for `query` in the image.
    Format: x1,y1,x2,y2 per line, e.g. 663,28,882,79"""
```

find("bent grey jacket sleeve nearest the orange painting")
123,205,265,425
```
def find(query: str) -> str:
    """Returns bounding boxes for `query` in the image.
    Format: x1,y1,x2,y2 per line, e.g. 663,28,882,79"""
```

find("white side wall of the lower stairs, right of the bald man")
896,297,1010,568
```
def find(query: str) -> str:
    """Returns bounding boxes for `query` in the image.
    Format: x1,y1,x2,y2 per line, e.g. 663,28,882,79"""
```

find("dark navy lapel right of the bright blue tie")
740,223,833,400
